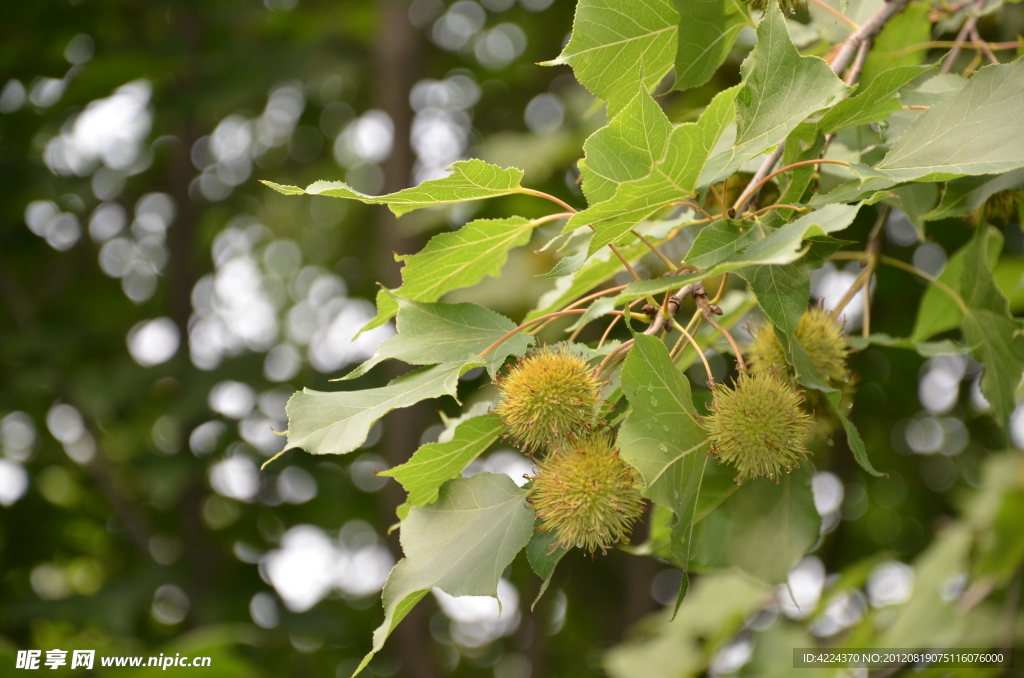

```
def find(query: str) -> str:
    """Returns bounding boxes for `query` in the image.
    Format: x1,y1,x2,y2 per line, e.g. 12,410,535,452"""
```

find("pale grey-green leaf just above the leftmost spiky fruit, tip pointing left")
344,297,532,379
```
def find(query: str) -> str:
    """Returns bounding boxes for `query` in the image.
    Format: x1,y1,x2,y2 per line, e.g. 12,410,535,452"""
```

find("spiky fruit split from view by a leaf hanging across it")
748,307,850,387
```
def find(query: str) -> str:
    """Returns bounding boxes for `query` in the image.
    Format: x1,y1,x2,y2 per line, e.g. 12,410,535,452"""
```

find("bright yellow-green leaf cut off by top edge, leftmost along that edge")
545,0,679,117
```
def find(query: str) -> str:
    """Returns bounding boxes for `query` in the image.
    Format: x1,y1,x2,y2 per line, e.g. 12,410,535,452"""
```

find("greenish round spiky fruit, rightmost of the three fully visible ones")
702,370,811,482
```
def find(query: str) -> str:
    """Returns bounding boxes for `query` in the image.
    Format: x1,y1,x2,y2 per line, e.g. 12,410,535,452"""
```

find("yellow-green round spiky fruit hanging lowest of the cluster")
526,433,643,553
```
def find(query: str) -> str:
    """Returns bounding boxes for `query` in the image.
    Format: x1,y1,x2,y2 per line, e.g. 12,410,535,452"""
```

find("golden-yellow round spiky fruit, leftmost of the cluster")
495,347,601,453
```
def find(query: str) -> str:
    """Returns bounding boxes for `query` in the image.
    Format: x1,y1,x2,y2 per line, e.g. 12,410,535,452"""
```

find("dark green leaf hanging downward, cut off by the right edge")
961,227,1024,430
